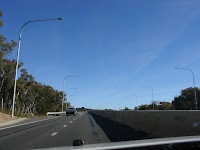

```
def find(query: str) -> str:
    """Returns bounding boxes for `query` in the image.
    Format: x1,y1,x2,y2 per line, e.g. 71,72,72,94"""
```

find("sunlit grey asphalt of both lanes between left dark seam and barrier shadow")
0,113,110,150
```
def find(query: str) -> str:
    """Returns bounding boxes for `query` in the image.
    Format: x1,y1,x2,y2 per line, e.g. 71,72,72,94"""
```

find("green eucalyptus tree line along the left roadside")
0,11,69,115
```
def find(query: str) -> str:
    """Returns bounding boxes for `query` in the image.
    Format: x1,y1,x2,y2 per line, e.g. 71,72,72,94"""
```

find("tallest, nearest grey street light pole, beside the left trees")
11,18,63,117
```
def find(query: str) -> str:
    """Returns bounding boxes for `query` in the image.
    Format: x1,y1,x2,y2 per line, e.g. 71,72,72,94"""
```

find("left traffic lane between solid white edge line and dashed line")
0,114,80,150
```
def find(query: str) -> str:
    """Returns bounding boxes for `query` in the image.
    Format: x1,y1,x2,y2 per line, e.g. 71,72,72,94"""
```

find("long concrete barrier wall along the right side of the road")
91,110,200,138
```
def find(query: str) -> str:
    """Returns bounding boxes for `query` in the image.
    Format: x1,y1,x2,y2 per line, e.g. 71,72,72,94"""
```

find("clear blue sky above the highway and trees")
0,0,200,109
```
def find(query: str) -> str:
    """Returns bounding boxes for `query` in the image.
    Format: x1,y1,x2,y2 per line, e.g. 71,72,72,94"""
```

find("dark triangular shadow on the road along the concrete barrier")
90,113,149,142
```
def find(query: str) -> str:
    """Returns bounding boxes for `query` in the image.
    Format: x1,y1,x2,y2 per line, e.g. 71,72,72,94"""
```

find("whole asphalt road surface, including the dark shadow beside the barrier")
0,112,147,150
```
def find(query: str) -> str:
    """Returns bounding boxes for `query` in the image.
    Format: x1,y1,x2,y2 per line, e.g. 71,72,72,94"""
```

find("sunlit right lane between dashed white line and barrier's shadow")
27,113,110,149
